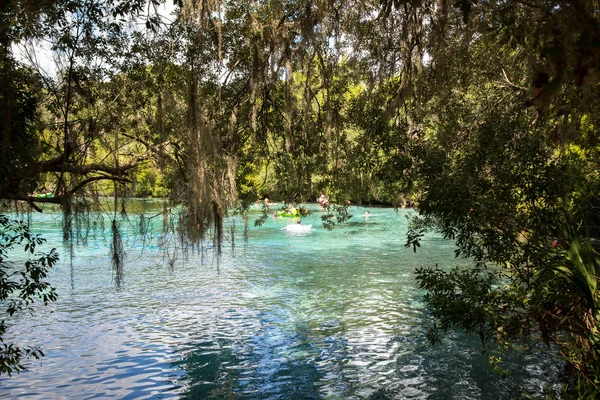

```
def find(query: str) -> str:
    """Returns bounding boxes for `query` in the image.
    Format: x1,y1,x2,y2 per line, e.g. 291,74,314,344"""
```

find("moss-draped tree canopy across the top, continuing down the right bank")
0,0,600,396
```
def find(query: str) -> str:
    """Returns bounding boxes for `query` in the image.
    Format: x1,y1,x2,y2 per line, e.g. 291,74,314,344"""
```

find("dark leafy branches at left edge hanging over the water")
0,215,58,376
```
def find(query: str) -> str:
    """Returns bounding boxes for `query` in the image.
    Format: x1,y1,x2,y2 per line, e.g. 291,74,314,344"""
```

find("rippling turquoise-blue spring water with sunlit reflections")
0,202,558,399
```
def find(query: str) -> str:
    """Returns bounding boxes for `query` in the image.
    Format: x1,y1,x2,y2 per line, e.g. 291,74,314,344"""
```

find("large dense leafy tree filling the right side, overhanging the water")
396,2,600,396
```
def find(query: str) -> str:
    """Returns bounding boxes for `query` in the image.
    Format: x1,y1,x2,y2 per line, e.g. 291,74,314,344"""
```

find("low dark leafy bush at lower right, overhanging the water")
416,220,600,398
